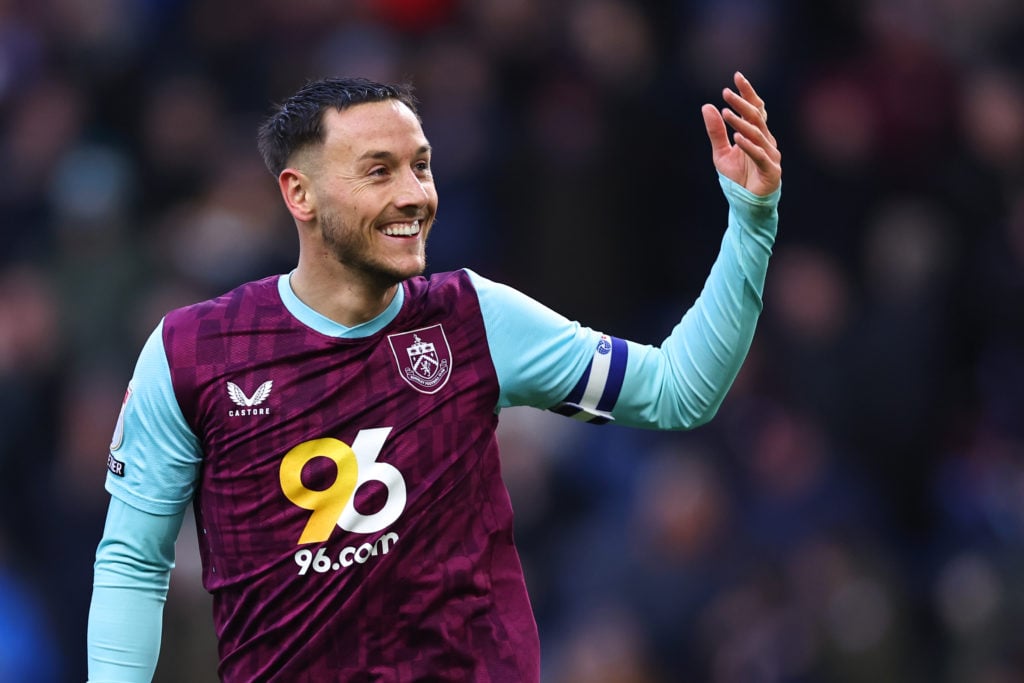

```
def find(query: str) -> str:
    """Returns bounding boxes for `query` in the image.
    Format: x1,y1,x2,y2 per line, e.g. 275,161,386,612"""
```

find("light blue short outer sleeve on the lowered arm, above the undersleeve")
106,321,202,515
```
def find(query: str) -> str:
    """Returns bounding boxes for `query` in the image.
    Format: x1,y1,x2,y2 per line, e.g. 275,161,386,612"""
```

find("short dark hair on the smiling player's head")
257,78,419,177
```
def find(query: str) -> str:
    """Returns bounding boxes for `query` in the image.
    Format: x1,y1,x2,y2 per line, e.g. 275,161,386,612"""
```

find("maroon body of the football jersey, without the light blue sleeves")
164,271,540,683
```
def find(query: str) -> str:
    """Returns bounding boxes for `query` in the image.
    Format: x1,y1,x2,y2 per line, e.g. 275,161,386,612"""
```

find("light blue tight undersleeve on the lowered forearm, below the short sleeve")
87,498,184,683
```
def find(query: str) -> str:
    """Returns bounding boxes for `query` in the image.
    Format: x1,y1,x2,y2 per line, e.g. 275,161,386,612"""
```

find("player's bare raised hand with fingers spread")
700,72,782,197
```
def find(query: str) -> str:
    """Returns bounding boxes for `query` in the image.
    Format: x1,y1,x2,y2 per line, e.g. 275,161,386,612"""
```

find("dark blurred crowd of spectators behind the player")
0,0,1024,683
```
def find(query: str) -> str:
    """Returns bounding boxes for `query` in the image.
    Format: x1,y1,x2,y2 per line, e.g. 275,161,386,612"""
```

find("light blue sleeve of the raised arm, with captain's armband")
470,176,780,429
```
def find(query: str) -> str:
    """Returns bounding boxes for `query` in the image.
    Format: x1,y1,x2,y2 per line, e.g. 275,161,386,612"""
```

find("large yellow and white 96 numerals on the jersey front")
281,427,407,545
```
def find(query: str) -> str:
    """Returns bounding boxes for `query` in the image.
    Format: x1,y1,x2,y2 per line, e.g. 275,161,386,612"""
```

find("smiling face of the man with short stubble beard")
301,100,437,286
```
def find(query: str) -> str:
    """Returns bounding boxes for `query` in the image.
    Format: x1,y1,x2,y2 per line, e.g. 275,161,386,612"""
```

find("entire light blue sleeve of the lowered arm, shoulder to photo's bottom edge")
87,323,202,683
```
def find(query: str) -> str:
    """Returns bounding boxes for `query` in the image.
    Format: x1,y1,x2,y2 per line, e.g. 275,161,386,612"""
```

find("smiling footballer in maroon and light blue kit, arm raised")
88,73,781,683
